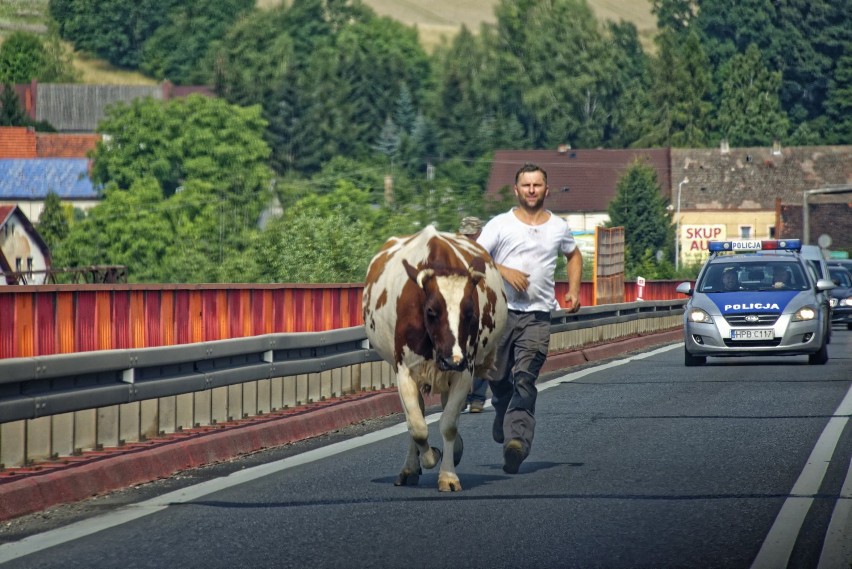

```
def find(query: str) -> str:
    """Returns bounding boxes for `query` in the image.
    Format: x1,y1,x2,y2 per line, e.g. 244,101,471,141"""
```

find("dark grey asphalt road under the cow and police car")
0,327,852,569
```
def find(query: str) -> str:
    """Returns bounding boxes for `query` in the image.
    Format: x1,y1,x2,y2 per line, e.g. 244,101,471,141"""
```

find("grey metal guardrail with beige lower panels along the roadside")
0,300,684,469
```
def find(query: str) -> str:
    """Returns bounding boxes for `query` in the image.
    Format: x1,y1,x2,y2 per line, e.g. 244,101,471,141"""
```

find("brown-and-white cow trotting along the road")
362,225,507,492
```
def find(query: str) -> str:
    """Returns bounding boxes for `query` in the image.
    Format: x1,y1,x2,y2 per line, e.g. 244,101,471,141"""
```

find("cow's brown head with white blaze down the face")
402,260,485,371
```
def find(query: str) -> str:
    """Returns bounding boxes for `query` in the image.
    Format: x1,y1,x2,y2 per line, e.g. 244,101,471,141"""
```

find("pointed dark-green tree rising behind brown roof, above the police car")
718,44,789,146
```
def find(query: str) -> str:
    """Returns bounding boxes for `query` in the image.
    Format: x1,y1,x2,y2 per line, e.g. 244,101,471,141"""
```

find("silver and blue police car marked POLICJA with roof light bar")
677,239,834,366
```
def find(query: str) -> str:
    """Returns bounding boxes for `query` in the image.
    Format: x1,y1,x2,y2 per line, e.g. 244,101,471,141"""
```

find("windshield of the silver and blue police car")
697,259,809,293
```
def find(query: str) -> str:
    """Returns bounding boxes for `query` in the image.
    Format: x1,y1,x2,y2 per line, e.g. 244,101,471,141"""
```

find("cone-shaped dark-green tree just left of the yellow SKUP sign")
607,160,674,278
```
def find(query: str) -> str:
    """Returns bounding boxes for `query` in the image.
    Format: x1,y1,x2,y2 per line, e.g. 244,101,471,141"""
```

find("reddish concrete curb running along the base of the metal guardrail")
0,330,683,521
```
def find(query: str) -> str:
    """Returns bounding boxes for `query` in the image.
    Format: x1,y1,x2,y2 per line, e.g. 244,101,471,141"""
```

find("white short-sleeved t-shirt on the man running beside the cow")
476,209,577,312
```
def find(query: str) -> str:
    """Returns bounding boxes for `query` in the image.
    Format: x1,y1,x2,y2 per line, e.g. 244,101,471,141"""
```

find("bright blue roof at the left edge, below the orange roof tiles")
0,158,99,200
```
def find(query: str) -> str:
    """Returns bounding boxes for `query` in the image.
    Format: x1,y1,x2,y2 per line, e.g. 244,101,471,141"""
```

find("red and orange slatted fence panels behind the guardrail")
0,281,681,358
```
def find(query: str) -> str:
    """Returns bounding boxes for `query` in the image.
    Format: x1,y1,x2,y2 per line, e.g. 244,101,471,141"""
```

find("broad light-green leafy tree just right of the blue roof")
92,95,271,213
